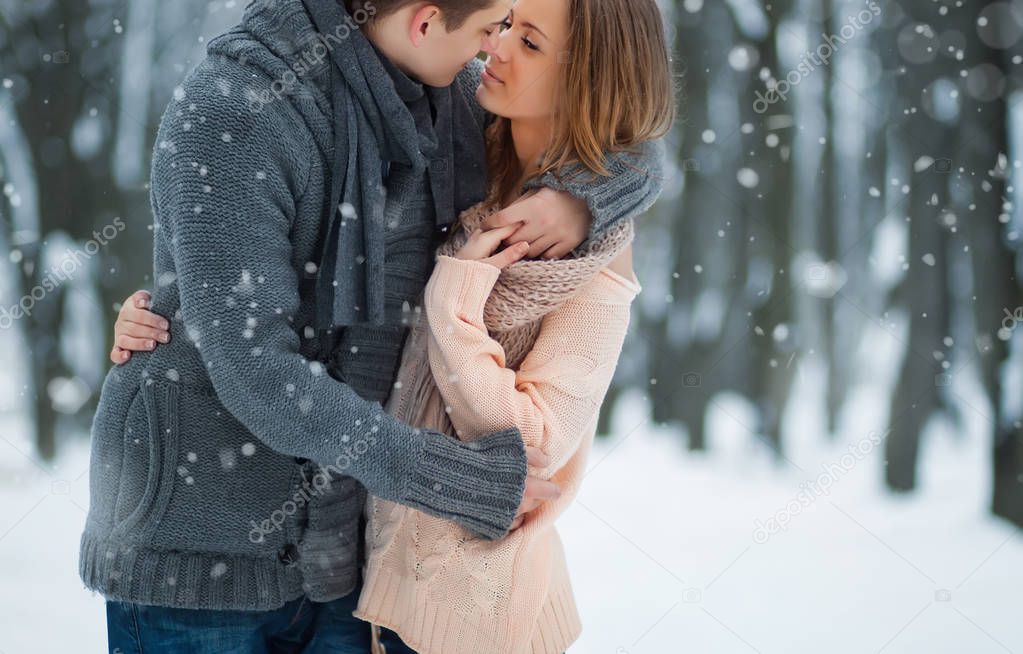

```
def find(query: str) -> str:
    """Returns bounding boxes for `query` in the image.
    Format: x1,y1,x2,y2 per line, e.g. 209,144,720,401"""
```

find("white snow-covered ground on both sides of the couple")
0,331,1023,654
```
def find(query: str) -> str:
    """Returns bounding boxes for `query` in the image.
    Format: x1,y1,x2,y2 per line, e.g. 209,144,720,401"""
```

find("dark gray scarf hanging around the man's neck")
303,0,486,330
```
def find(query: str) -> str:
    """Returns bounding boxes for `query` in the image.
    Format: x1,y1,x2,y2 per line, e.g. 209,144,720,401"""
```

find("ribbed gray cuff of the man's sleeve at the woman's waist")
401,427,527,540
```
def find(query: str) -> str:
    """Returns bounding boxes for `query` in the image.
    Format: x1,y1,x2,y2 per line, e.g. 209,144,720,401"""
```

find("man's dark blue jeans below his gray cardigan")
106,586,370,654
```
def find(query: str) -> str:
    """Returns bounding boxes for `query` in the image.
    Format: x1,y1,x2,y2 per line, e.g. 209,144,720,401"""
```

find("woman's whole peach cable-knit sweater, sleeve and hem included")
354,224,641,654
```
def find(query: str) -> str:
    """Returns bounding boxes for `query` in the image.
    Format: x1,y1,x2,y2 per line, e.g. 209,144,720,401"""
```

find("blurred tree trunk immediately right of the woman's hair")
643,2,745,449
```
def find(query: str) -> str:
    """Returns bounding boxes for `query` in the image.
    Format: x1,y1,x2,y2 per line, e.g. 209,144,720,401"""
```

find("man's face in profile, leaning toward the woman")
406,0,515,87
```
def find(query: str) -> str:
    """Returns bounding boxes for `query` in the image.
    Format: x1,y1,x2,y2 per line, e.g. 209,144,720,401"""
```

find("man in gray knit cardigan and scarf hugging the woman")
80,0,661,653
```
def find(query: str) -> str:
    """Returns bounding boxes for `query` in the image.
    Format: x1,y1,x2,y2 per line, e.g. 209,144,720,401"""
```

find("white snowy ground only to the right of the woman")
562,393,1023,654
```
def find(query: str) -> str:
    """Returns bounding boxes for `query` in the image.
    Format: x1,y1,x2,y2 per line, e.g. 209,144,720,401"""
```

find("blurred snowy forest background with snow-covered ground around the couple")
0,0,1023,654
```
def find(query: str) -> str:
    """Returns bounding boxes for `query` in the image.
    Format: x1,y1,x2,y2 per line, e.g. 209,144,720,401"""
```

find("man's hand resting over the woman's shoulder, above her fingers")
482,188,593,259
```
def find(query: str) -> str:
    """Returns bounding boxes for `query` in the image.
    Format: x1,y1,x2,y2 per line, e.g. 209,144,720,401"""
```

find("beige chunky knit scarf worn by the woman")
387,203,634,437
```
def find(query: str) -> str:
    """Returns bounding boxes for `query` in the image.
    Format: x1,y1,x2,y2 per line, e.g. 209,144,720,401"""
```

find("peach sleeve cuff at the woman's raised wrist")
427,255,501,324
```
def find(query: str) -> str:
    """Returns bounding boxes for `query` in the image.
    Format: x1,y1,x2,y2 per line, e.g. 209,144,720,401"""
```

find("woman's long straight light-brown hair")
487,0,676,204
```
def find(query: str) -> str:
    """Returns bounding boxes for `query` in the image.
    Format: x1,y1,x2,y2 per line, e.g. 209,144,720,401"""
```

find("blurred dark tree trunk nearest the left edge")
0,0,123,460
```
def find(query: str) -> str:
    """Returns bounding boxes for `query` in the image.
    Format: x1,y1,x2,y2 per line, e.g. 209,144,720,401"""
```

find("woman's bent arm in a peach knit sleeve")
426,247,640,476
